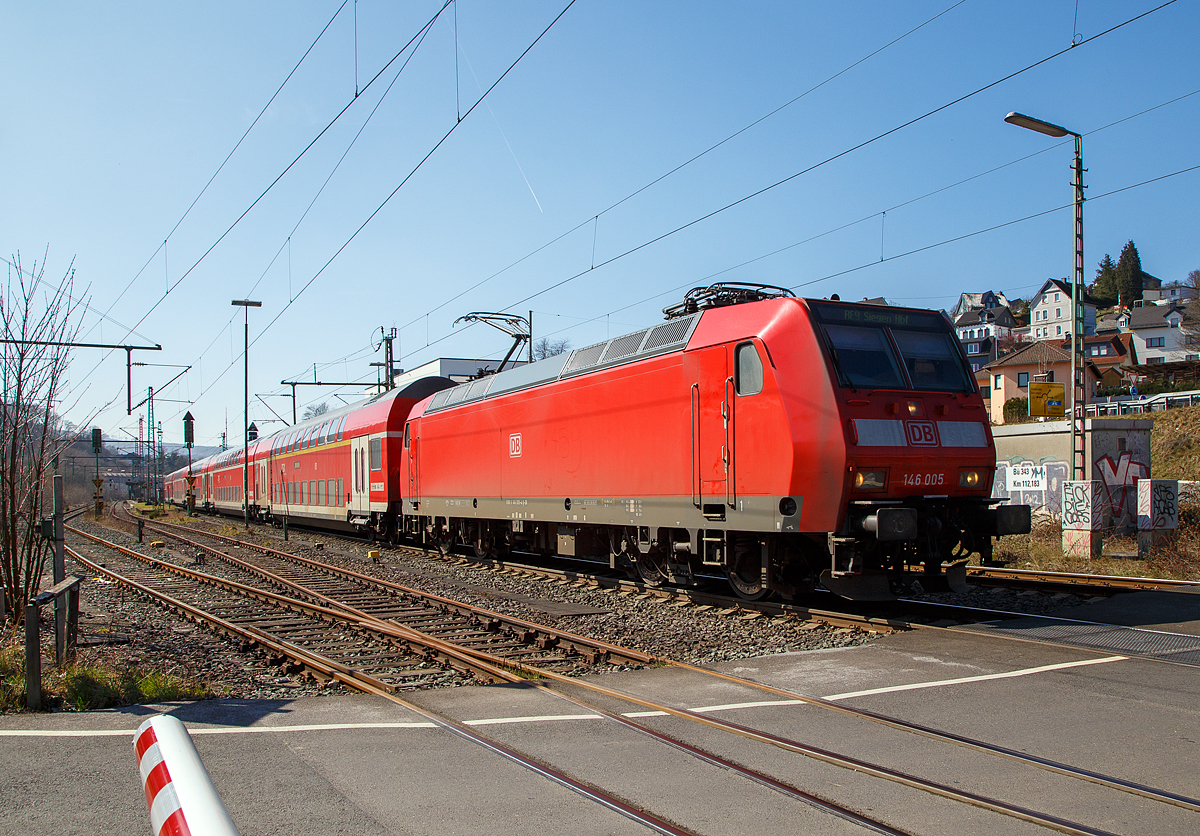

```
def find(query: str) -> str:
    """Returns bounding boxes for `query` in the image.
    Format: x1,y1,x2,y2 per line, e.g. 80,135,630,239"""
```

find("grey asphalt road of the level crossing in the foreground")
0,593,1200,836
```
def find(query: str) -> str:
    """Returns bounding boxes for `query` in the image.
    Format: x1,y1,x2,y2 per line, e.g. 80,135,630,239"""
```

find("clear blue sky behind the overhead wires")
0,0,1200,444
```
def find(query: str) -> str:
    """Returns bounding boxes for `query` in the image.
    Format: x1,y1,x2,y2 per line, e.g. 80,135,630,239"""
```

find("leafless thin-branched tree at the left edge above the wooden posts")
0,253,84,621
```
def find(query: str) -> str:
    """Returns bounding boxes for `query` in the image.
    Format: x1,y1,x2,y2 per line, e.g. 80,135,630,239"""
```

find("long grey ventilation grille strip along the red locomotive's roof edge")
425,313,701,413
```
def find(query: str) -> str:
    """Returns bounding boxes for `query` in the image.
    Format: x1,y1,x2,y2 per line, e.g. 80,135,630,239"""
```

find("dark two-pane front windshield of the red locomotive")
810,302,974,392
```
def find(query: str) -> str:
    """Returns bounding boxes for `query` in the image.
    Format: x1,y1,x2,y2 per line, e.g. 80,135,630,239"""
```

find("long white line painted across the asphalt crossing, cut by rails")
0,656,1128,738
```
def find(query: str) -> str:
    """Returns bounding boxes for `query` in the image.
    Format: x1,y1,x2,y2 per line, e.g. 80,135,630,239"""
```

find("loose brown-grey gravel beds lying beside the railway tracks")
46,510,1099,699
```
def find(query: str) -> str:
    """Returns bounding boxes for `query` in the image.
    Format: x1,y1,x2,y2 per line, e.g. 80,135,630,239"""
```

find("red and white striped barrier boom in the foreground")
133,715,238,836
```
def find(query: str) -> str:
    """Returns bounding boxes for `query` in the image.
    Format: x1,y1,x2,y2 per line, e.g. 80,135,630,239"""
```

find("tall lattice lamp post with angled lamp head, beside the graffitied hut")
1004,112,1087,481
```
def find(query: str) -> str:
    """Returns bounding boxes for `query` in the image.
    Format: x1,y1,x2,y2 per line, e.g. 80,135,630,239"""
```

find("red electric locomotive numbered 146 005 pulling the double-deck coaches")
401,284,1030,599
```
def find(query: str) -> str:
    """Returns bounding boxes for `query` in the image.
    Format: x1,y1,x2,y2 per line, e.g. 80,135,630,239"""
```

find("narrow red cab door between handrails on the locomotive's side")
691,345,732,508
